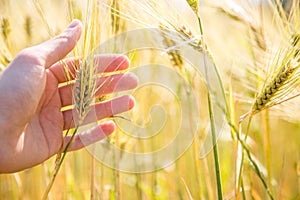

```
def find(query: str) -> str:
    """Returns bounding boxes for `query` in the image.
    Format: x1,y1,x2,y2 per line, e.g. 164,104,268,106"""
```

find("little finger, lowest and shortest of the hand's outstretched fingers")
63,121,116,151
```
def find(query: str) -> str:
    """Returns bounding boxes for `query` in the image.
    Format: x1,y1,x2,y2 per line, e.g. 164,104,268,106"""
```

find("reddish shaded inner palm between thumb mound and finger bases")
24,71,63,164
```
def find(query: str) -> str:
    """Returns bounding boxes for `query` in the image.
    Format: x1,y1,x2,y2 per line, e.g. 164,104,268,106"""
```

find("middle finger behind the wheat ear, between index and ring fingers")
59,73,138,107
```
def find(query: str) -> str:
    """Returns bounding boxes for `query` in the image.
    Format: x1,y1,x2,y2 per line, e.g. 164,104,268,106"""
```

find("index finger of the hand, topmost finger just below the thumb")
49,54,129,83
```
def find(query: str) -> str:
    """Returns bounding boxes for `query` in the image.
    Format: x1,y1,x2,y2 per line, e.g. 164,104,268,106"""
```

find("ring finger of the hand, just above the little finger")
63,95,135,130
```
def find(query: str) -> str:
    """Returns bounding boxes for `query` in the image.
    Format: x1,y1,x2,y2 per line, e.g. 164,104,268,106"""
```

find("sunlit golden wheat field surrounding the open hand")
0,0,300,200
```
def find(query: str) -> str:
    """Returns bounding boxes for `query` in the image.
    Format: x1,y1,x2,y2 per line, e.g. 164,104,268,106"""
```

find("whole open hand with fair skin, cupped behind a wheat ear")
0,20,137,173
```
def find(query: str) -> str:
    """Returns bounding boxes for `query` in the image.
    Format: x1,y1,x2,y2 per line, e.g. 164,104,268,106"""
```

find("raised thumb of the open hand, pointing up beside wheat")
33,20,82,68
